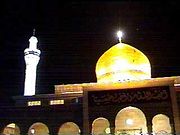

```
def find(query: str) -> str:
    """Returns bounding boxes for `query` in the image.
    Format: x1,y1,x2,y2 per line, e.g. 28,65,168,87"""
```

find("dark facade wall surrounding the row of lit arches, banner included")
0,86,180,135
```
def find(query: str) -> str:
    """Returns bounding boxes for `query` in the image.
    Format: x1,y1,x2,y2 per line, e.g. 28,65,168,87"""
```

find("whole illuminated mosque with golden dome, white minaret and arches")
0,32,180,135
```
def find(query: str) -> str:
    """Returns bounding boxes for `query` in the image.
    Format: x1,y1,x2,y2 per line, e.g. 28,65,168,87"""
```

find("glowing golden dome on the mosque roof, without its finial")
96,43,151,83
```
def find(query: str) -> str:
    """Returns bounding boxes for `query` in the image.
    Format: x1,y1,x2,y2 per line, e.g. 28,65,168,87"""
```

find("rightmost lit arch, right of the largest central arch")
152,114,171,135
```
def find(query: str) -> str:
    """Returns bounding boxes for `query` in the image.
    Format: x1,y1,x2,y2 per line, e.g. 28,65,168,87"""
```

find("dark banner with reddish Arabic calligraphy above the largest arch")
88,86,170,105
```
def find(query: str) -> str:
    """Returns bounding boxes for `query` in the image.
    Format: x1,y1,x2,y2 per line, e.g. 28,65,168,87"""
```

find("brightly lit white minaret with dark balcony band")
24,33,41,96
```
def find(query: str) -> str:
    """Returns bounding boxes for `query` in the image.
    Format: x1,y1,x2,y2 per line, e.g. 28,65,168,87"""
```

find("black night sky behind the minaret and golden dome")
0,0,180,95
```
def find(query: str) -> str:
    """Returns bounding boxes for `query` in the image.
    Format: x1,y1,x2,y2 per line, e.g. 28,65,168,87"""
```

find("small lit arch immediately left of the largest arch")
91,117,110,135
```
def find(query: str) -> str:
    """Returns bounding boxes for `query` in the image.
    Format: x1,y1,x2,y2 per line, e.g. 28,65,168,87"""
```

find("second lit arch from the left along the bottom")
28,122,49,135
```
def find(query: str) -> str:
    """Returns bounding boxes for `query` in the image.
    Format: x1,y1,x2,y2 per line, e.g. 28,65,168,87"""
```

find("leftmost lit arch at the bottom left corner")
2,123,20,135
